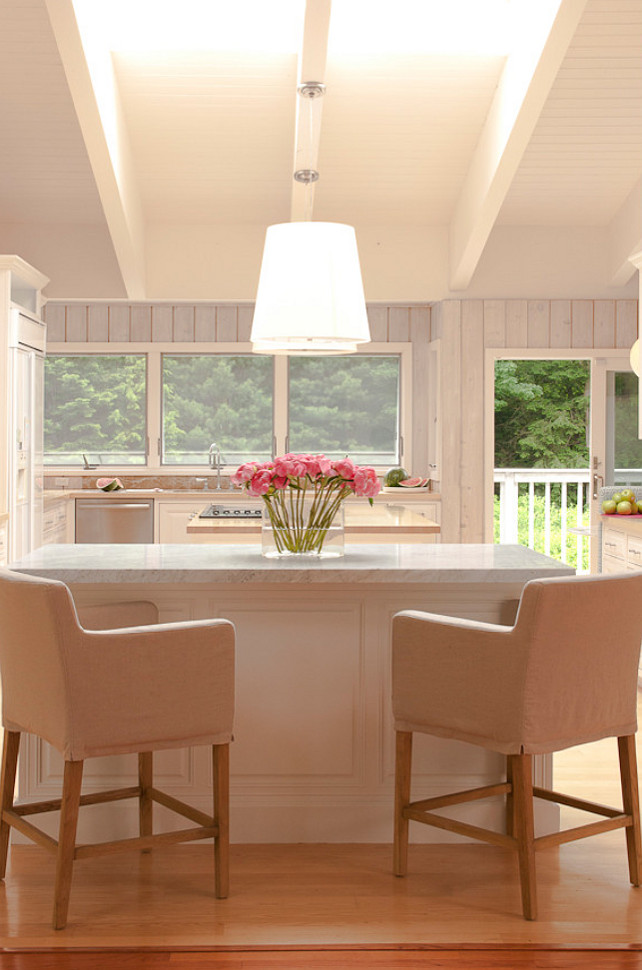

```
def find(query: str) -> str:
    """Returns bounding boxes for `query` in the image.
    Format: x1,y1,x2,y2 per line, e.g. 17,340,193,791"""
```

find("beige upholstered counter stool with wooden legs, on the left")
0,570,235,929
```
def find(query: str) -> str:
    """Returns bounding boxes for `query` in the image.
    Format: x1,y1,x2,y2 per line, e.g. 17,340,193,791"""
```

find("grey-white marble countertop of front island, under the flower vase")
10,543,574,584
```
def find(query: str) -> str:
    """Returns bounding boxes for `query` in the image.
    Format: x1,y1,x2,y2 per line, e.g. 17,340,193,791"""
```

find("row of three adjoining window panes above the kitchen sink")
45,344,404,474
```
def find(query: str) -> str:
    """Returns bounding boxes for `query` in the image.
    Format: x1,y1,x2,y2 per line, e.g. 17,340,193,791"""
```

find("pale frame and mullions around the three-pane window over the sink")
46,341,413,476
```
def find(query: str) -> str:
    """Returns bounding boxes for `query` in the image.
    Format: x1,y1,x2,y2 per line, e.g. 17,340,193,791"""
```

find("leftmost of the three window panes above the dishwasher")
44,354,147,465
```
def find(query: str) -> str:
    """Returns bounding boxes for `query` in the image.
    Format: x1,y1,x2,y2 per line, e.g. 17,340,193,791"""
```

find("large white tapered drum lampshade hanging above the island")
250,222,370,355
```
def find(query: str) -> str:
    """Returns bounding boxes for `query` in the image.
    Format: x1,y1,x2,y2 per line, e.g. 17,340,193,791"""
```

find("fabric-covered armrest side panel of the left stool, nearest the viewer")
59,620,234,760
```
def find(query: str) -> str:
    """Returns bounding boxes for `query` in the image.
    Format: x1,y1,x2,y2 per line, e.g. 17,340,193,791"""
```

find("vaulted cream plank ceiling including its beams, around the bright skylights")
0,0,642,301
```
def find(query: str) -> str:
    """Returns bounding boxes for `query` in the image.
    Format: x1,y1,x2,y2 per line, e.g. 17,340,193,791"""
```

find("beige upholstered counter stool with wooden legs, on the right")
392,573,642,919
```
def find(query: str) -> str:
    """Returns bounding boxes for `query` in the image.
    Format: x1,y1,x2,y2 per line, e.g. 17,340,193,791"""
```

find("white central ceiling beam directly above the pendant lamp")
290,0,332,222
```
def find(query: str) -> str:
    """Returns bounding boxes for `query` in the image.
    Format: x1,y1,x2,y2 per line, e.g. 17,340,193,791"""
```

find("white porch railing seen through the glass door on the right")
495,468,590,572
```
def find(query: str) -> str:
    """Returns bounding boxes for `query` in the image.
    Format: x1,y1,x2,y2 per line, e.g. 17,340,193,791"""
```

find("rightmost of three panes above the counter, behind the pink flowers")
288,354,400,465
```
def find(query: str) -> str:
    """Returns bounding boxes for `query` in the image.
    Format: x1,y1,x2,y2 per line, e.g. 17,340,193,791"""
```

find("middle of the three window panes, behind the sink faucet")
162,354,274,465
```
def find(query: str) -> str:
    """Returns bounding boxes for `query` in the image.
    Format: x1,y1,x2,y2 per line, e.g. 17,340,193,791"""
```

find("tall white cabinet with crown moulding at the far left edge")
0,256,49,565
